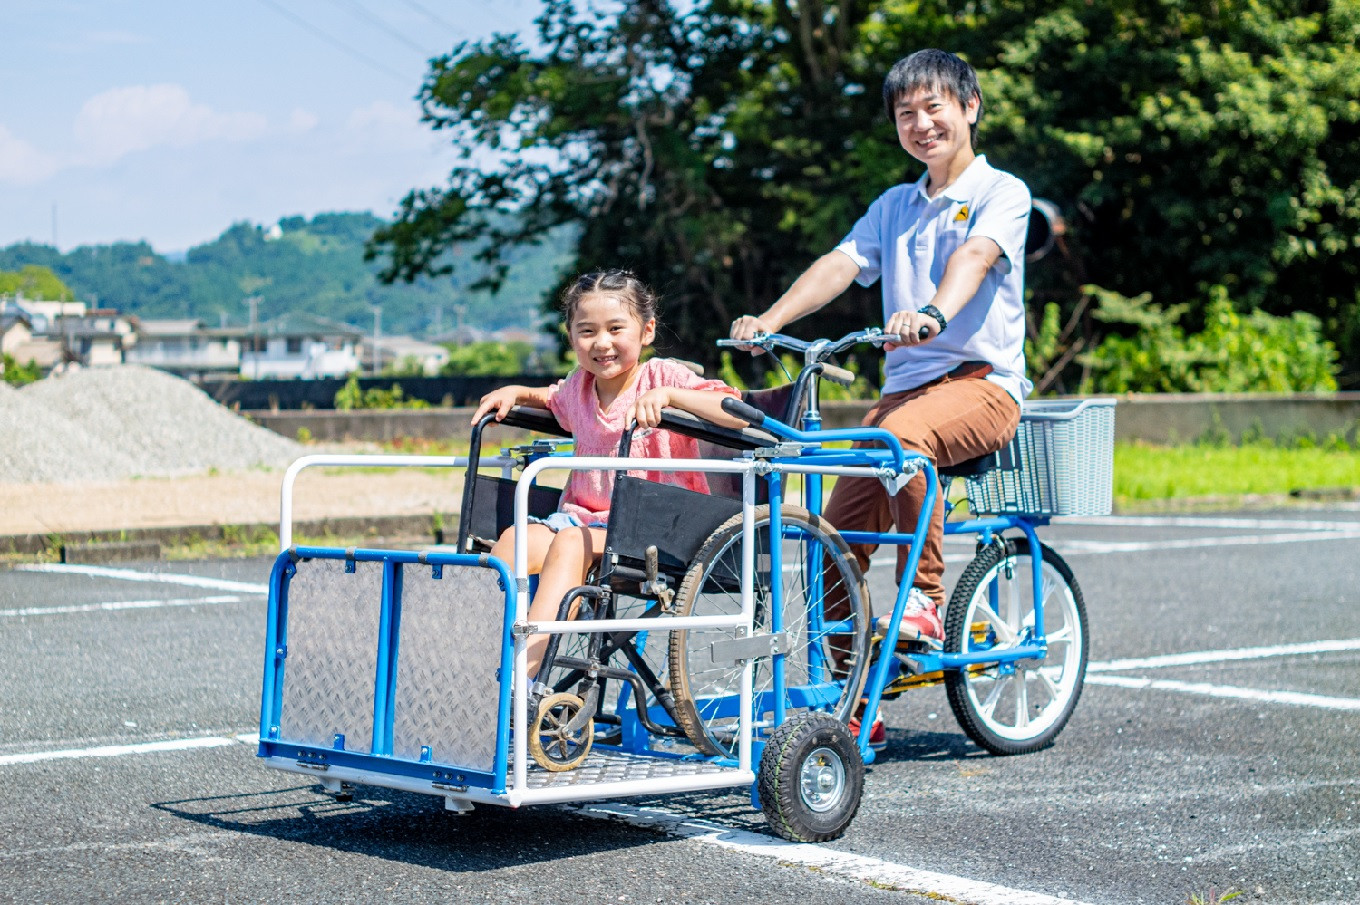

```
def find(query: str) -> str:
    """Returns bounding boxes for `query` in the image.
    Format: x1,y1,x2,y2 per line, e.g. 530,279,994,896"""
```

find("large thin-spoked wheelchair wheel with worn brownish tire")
668,505,870,757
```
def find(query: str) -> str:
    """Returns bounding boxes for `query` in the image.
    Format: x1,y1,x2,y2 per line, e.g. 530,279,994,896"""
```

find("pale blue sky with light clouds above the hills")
0,0,540,252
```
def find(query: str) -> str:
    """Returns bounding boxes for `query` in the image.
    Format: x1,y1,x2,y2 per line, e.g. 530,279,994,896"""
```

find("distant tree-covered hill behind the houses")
0,212,573,336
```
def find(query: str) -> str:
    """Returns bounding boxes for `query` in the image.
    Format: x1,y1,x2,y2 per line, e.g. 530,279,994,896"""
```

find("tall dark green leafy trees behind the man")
370,0,1360,391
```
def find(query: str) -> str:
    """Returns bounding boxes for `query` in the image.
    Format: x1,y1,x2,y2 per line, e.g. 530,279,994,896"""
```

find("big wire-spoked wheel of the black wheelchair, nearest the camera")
668,505,870,757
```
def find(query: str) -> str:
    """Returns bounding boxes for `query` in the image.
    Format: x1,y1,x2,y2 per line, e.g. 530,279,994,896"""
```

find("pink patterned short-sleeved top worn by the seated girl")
548,358,741,525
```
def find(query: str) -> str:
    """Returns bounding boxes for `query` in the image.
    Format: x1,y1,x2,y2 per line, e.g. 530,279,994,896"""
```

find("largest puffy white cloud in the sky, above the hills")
75,84,268,166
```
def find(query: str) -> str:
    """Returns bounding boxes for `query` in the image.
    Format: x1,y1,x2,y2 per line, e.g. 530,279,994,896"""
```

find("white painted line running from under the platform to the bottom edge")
564,803,1080,905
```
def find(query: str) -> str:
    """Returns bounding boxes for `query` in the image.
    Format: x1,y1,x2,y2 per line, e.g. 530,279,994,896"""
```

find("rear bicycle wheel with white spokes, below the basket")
944,538,1088,754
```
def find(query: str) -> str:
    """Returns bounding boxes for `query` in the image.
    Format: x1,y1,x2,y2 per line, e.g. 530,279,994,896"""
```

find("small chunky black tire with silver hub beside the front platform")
756,713,864,842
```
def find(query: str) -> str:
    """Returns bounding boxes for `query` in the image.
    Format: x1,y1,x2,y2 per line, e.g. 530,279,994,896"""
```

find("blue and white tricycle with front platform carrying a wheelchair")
258,329,1114,841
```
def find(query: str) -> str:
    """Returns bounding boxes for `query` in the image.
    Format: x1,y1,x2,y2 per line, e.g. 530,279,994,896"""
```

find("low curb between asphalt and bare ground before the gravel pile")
0,516,446,562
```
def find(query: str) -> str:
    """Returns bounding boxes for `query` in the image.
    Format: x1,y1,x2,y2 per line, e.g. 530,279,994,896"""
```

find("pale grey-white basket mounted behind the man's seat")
967,399,1115,516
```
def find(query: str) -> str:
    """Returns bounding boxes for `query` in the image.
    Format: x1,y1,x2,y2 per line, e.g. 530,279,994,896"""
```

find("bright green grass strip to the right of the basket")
1114,442,1360,509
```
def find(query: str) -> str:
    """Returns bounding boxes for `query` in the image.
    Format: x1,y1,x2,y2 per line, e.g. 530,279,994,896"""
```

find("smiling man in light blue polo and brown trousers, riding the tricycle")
730,50,1032,747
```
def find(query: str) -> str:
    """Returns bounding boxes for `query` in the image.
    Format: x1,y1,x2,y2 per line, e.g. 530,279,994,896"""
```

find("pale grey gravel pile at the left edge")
0,365,303,483
